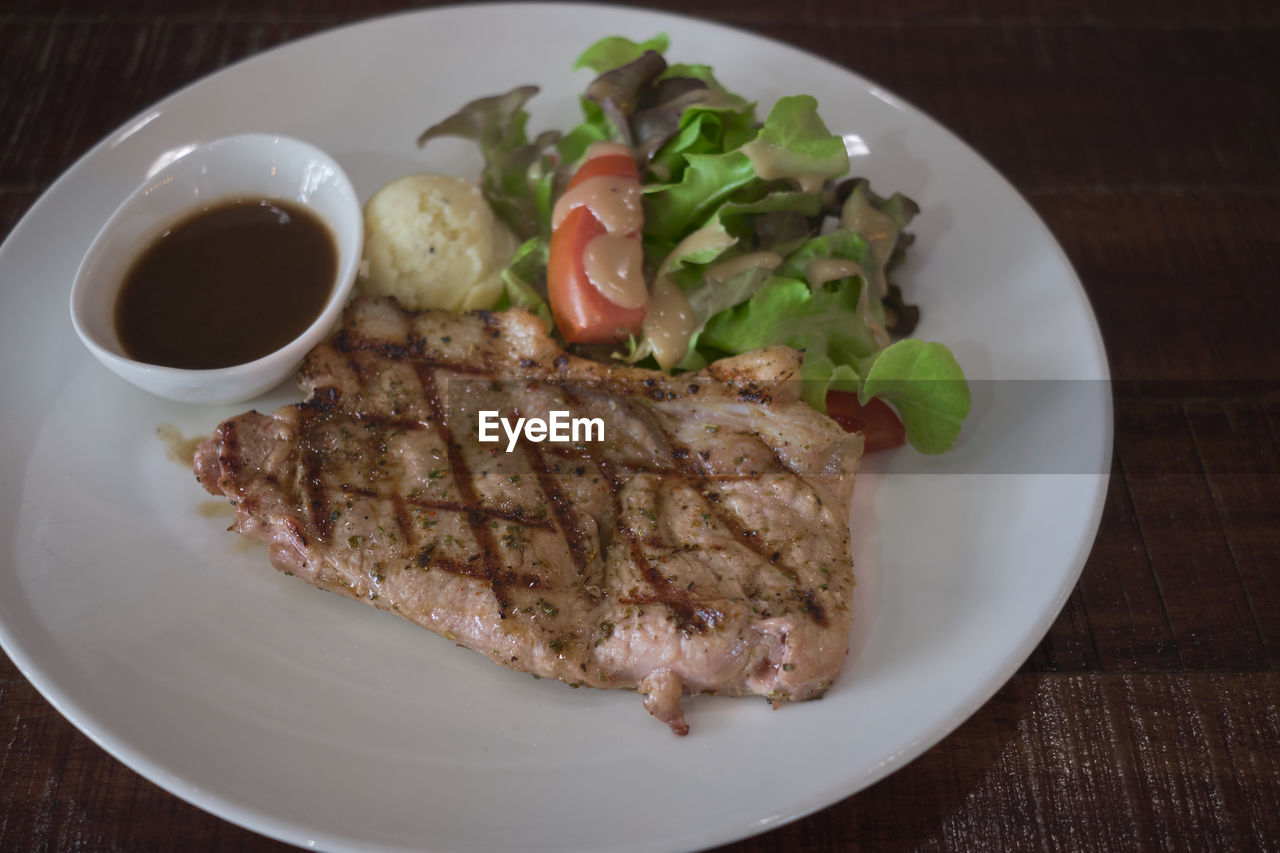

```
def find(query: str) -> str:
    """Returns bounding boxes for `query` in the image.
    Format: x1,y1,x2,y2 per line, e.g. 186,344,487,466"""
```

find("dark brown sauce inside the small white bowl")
115,199,338,370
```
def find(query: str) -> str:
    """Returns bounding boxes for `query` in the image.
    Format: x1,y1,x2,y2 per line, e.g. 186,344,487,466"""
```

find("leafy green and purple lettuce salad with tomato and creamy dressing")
419,35,970,453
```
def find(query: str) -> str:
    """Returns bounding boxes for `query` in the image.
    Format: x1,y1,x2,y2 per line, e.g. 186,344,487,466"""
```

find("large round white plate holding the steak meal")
0,5,1111,850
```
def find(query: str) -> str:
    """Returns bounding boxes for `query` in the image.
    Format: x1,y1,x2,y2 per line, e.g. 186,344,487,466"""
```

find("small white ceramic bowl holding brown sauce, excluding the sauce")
70,133,364,403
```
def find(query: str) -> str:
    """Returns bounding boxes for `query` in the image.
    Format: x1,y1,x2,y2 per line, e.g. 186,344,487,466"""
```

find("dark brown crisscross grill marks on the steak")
294,332,826,633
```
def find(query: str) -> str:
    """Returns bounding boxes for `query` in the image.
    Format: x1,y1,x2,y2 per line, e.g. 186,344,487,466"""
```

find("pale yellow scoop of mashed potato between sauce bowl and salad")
356,174,517,311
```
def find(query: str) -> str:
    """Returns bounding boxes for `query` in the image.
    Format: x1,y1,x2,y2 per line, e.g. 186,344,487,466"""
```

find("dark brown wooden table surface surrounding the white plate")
0,0,1280,850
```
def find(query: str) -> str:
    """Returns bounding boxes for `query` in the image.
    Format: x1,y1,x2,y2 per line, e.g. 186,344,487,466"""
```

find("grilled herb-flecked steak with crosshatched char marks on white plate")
195,298,861,734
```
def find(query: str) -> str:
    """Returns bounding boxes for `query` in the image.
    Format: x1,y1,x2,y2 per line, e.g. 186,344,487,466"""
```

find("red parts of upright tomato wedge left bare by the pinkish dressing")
547,151,646,343
